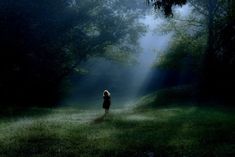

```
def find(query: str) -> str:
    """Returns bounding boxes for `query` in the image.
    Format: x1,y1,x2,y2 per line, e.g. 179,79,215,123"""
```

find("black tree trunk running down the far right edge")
202,0,235,100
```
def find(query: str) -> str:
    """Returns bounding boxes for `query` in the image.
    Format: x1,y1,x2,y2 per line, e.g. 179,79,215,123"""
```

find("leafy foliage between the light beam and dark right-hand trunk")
152,5,207,89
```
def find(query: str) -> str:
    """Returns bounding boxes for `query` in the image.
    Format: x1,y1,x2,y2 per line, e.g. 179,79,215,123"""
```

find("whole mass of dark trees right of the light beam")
147,0,235,101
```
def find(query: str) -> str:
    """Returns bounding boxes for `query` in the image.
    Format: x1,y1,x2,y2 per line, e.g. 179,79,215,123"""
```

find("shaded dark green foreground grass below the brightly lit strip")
0,107,235,157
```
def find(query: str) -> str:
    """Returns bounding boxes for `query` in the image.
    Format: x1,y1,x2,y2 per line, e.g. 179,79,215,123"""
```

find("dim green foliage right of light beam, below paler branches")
156,36,206,70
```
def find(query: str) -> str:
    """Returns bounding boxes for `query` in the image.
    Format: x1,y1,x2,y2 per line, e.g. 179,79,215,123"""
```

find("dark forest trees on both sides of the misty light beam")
0,0,235,108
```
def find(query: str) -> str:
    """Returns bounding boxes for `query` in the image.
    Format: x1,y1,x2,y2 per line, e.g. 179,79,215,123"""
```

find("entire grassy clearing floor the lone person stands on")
0,96,235,157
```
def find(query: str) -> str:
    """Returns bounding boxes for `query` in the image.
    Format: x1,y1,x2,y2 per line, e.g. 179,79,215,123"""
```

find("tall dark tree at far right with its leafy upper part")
147,0,235,100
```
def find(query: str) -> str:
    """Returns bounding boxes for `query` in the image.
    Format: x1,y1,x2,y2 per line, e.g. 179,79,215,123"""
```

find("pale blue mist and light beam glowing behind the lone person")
63,14,172,108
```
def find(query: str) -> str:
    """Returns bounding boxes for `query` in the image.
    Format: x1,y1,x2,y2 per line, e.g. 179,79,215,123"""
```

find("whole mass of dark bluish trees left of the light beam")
0,0,144,106
